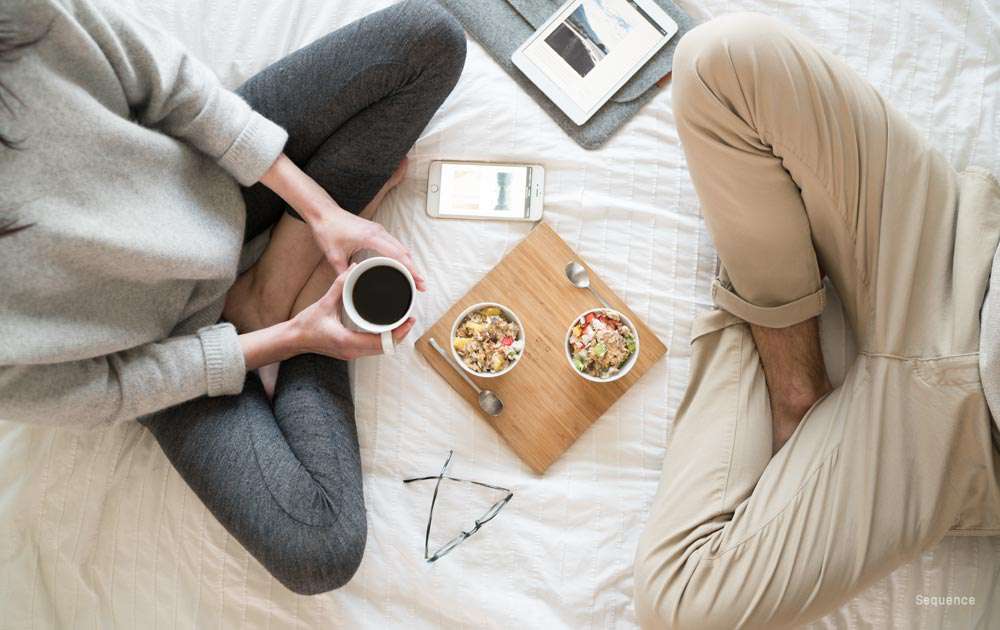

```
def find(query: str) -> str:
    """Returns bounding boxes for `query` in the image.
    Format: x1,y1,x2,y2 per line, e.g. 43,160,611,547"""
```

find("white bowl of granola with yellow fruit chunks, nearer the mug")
451,302,525,378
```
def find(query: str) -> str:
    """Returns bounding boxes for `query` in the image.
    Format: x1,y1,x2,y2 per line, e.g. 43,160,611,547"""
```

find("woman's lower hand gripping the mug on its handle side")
290,270,414,361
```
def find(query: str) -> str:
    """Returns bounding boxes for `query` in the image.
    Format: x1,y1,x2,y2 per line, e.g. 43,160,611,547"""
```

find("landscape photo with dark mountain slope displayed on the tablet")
545,0,632,77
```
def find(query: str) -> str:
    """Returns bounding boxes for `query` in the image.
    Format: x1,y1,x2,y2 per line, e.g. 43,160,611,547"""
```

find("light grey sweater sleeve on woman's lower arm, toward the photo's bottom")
0,324,246,426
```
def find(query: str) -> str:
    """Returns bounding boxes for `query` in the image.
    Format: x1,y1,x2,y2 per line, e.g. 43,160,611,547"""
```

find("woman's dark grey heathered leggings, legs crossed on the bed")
143,0,465,594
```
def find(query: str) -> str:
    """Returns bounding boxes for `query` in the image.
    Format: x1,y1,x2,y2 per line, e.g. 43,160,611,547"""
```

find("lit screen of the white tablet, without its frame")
524,0,667,111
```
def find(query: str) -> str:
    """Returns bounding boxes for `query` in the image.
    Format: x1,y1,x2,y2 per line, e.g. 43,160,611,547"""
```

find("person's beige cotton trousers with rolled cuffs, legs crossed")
635,15,1000,630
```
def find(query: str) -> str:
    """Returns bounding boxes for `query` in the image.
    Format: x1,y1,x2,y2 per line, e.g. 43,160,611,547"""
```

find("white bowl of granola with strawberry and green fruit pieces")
565,308,639,383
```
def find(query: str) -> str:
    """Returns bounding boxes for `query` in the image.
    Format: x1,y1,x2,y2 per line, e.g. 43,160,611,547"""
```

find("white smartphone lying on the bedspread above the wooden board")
427,160,545,221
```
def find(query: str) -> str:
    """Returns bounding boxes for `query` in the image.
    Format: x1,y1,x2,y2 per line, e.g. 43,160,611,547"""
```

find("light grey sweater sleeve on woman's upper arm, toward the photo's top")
62,0,288,186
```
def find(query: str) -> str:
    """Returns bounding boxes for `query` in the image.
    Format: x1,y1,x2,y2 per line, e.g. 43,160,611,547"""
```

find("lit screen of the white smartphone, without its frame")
438,162,531,219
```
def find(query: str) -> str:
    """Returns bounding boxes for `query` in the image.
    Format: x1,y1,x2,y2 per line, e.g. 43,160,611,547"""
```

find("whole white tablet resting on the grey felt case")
511,0,677,125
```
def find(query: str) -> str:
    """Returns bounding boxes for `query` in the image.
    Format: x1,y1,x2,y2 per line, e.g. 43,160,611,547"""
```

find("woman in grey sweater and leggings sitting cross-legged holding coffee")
0,0,465,594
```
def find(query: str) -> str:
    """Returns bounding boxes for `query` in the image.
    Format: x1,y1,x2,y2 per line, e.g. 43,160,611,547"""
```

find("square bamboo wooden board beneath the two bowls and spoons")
416,223,667,474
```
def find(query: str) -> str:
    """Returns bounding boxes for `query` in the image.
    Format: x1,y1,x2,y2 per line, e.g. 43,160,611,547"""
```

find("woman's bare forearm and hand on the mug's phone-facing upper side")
261,154,426,291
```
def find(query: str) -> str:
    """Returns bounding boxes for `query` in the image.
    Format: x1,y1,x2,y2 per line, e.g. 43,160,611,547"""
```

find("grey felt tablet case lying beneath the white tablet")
436,0,694,149
